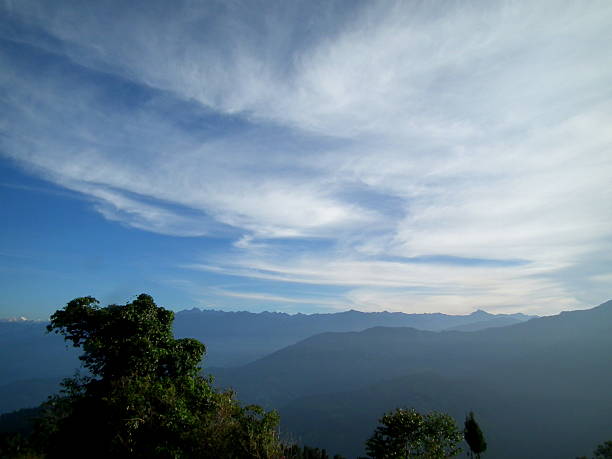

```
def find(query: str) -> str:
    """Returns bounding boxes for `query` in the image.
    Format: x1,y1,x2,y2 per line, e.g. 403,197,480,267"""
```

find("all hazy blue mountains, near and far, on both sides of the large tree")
0,301,612,459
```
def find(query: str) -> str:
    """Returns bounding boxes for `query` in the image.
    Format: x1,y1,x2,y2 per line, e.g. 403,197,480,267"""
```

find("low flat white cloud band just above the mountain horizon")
183,254,583,314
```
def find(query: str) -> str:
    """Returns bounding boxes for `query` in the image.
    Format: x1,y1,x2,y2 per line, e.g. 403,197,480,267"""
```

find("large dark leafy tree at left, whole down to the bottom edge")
35,294,280,458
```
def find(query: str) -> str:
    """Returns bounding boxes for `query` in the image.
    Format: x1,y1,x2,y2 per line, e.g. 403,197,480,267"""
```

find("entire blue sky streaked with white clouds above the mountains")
0,0,612,319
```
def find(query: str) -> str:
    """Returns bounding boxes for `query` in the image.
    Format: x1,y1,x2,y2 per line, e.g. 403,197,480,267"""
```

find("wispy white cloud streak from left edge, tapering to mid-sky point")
3,38,377,237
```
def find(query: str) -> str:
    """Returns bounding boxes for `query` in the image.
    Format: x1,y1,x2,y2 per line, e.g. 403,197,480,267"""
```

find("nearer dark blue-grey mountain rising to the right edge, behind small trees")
215,301,612,458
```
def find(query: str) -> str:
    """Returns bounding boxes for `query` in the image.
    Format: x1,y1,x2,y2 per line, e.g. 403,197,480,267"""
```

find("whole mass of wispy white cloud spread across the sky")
0,0,612,313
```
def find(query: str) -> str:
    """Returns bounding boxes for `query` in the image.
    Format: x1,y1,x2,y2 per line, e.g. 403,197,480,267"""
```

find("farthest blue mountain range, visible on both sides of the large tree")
0,308,530,413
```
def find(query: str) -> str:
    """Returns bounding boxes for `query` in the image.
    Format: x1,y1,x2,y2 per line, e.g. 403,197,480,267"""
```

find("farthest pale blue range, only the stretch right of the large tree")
174,308,533,367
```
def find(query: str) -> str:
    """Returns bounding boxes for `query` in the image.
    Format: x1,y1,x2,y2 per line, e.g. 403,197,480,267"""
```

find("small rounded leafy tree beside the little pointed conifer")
366,409,461,459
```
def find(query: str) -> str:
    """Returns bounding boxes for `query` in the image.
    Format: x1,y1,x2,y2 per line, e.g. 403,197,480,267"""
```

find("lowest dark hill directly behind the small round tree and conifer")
279,372,612,459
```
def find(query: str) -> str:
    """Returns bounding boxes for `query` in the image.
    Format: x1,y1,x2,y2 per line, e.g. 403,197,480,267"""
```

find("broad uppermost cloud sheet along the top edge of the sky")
7,1,612,138
